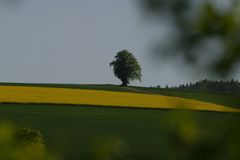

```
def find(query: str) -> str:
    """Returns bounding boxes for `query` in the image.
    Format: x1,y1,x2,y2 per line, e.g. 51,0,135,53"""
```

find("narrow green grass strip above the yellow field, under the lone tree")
0,83,240,108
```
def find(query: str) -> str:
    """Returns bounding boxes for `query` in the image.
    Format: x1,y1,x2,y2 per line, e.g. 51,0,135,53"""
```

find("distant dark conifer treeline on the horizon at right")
157,79,240,93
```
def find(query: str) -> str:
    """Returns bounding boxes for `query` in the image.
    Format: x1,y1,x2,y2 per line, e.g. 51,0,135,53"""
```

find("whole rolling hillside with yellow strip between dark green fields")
0,84,240,160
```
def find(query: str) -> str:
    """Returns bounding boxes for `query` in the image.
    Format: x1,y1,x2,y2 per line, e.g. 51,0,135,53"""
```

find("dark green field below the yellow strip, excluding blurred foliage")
0,104,240,160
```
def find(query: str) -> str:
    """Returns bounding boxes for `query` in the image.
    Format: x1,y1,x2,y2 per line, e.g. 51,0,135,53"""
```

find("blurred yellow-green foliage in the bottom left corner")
0,122,59,160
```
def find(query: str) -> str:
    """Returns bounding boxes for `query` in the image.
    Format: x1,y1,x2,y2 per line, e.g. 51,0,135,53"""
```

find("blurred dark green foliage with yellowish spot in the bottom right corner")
166,111,240,160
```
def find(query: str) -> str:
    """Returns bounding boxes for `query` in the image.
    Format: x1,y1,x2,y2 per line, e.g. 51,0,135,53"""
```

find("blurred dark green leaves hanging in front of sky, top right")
140,0,240,76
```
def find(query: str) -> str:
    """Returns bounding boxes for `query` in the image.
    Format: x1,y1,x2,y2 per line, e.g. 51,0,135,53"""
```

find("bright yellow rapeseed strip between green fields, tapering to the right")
0,86,239,112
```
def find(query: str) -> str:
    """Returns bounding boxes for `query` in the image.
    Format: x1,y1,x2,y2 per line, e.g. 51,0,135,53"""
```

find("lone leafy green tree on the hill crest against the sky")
110,50,142,86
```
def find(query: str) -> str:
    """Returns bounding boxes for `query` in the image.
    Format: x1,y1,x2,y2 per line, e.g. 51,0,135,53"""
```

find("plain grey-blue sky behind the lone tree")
0,0,239,86
